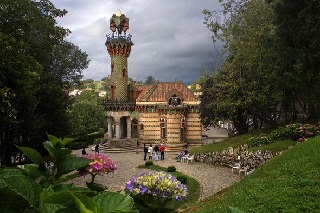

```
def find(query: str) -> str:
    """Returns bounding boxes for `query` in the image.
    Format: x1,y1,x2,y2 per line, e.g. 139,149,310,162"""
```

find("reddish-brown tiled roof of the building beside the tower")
135,81,197,102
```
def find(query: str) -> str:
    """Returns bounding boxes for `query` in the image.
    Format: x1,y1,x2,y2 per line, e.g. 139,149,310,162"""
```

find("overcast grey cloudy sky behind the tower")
51,0,219,83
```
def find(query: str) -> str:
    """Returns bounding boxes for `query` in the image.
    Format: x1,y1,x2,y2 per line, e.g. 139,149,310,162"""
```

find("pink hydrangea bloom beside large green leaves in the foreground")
79,153,117,183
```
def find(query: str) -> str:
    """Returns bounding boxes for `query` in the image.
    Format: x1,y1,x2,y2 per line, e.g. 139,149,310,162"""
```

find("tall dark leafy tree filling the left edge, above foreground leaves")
0,0,89,165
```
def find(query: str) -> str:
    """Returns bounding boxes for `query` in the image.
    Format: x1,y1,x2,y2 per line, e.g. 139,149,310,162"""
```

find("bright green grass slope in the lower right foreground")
192,137,320,213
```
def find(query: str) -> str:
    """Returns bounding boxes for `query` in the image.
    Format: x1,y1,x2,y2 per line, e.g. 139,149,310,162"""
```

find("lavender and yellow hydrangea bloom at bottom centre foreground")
126,171,188,212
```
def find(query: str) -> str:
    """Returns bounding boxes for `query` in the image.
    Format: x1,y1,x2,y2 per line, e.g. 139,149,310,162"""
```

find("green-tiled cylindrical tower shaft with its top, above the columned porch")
105,10,133,102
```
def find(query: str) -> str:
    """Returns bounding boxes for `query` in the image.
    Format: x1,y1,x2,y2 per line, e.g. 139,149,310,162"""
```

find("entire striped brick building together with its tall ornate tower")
104,11,202,150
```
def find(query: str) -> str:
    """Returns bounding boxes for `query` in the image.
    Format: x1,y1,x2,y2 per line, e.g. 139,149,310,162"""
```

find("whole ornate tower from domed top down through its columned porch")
104,10,135,140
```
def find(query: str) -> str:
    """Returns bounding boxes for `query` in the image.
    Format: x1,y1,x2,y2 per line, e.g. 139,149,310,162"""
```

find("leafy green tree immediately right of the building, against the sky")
201,0,282,133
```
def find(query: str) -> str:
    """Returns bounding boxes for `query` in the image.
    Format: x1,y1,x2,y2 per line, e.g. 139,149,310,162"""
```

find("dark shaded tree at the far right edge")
269,0,320,118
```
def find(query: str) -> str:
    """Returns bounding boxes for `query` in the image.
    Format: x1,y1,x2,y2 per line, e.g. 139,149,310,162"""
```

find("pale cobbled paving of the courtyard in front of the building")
72,150,240,200
